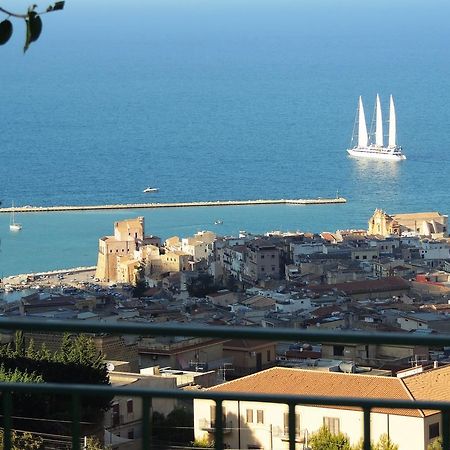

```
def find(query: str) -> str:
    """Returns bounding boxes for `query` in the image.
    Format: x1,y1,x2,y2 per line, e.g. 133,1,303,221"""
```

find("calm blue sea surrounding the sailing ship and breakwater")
0,0,450,277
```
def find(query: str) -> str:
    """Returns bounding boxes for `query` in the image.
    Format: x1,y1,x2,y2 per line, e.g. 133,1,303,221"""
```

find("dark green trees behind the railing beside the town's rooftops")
0,333,111,436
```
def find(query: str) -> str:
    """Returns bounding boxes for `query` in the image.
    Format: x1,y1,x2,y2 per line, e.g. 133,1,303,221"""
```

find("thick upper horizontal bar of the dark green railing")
0,318,450,346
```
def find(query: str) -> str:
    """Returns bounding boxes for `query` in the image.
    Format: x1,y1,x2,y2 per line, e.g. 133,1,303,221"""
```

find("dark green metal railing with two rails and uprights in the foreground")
0,318,450,450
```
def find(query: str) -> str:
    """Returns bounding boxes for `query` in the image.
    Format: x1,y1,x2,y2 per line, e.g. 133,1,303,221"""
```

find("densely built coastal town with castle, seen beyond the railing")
1,209,450,449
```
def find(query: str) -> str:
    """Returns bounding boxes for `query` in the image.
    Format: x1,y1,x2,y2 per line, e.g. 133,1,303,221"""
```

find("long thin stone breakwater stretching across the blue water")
0,197,347,213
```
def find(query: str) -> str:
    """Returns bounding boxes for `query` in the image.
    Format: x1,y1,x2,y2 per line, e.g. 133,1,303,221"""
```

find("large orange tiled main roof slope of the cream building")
209,367,423,417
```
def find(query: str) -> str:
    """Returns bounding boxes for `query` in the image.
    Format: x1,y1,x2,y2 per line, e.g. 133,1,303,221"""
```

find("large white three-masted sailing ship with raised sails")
347,94,406,161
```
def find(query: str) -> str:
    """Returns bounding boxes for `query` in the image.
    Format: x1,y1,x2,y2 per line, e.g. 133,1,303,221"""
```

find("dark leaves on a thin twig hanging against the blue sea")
0,1,65,52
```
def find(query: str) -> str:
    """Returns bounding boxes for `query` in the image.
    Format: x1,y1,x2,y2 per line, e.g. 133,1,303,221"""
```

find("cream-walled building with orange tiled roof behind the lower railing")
194,366,450,450
